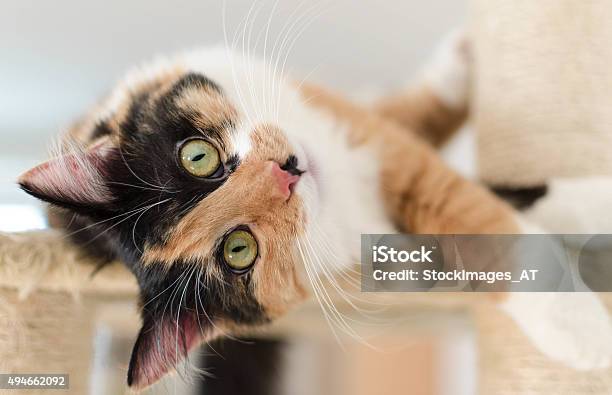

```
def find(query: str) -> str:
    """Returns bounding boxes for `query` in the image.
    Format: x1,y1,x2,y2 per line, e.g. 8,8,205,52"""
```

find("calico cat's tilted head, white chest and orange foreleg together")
19,48,532,389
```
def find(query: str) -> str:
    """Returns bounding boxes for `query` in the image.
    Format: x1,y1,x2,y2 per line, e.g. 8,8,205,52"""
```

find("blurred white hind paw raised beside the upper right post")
424,30,472,108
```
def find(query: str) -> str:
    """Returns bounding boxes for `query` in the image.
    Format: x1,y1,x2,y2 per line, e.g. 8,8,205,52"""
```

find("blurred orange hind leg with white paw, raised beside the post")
375,30,471,146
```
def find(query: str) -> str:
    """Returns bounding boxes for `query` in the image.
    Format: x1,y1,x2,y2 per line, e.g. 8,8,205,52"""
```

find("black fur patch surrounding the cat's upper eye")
69,74,238,262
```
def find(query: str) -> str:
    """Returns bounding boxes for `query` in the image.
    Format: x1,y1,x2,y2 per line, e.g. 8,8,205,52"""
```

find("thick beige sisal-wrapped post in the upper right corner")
468,0,612,188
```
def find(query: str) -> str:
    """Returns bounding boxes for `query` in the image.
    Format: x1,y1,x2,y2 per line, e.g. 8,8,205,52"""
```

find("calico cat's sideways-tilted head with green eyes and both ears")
19,50,317,388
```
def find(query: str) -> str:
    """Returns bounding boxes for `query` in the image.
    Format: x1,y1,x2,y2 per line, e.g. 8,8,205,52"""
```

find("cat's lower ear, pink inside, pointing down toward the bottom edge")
127,312,203,390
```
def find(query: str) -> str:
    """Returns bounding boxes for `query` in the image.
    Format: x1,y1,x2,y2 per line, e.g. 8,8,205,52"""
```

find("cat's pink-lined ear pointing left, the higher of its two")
18,138,117,210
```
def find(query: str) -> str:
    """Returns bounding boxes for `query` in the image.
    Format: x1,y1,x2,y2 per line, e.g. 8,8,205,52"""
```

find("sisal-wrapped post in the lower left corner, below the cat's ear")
0,231,138,394
